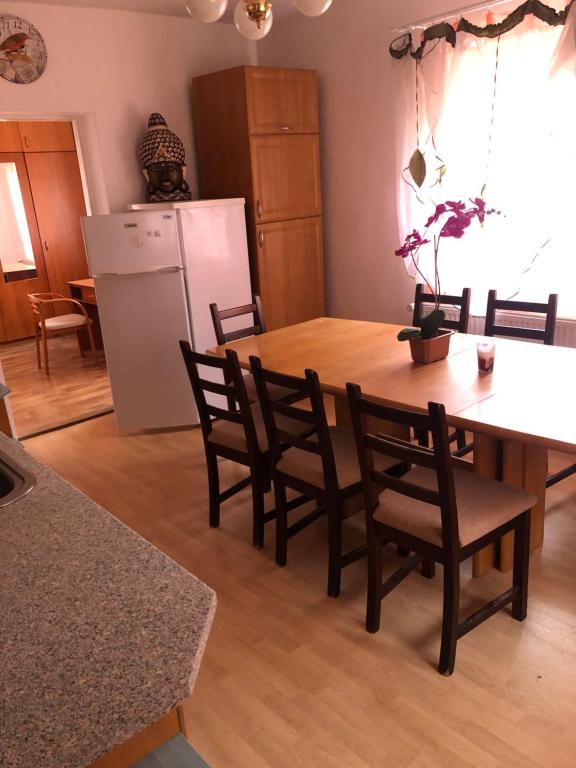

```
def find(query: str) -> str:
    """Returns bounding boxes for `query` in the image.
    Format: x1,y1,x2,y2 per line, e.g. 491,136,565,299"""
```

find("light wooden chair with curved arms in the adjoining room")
28,293,96,376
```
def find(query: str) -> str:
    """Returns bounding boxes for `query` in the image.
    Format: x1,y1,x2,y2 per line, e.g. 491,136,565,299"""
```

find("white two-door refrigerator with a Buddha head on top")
82,198,251,431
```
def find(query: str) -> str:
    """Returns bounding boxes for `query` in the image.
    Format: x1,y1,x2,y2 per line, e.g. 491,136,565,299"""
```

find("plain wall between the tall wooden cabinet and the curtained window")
258,0,480,323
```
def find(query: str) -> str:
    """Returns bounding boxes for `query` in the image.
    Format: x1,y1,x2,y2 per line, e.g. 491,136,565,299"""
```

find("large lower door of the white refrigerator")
95,269,198,431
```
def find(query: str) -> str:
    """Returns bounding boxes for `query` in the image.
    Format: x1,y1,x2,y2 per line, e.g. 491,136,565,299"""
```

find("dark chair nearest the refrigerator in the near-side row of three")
180,341,316,547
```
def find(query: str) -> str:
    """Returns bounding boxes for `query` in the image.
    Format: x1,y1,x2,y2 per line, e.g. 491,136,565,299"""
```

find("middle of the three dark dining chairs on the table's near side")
250,357,398,597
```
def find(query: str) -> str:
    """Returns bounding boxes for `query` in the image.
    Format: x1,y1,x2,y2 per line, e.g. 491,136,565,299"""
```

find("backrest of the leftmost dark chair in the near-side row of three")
180,341,259,456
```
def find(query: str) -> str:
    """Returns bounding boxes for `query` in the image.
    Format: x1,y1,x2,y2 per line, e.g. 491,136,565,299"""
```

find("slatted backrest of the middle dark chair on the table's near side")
250,357,338,491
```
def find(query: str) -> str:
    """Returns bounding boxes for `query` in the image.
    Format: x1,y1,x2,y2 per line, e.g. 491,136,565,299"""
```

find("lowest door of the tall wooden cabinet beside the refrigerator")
257,216,325,331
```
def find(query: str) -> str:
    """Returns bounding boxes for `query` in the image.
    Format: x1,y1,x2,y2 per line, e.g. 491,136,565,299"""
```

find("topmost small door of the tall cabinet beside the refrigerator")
246,67,318,133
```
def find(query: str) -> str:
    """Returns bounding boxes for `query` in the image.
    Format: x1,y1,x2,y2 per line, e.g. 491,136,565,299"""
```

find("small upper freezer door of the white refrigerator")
82,211,182,278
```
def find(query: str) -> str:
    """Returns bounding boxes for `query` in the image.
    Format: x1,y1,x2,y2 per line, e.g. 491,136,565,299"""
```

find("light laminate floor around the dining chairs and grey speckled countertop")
25,416,576,768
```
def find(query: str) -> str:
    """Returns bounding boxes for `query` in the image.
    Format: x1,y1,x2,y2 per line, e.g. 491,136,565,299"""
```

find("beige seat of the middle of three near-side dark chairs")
276,427,398,490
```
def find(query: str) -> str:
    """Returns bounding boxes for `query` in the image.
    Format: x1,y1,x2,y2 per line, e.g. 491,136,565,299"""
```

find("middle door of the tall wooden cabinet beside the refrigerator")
250,133,322,224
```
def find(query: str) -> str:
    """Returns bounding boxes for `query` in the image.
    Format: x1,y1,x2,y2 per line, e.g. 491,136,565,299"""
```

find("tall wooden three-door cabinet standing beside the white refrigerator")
192,67,325,330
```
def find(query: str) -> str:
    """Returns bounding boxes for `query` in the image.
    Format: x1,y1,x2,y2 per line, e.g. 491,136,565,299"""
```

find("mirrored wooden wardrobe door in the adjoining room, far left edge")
0,153,49,341
